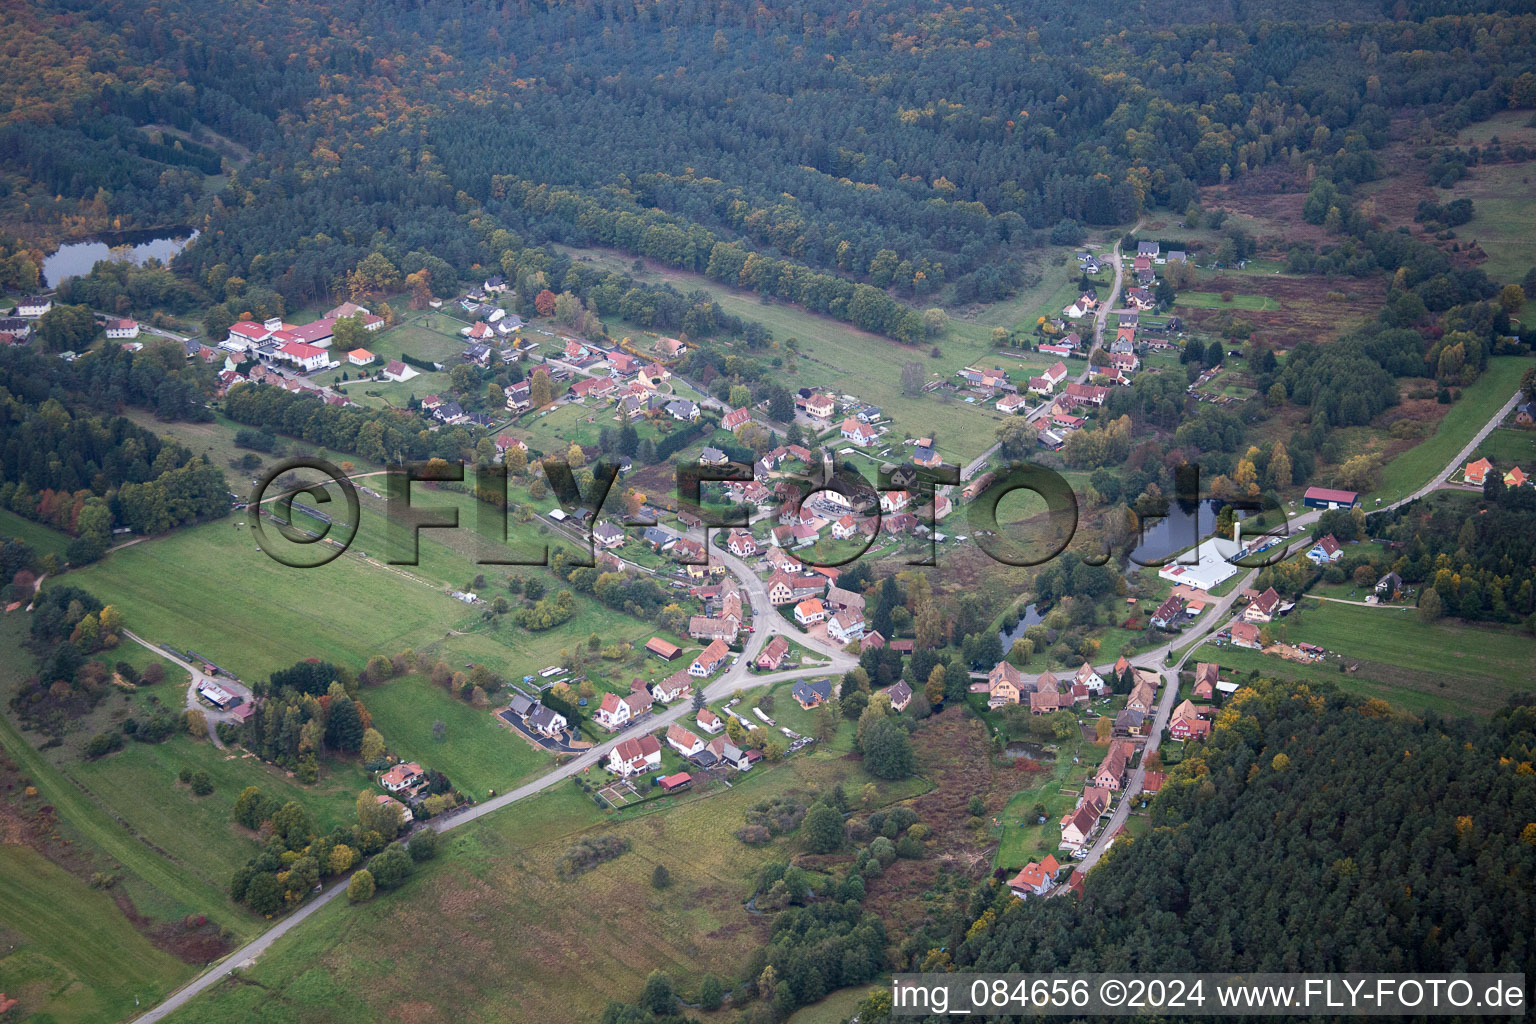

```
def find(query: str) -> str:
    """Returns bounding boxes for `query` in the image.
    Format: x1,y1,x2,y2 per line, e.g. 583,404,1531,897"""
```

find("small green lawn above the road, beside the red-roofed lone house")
361,676,551,800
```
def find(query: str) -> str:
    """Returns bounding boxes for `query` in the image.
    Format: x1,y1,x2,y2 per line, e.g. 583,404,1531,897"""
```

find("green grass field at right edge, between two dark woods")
1197,600,1536,715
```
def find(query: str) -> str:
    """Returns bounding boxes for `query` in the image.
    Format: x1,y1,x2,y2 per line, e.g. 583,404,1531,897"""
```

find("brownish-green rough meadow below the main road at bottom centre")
158,754,911,1024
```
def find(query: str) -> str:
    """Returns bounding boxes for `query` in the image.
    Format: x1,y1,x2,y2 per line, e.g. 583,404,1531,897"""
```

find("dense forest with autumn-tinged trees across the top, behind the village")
0,0,1536,322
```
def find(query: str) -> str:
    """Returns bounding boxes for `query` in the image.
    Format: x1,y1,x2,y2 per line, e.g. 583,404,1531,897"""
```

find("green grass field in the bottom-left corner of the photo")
0,843,192,1024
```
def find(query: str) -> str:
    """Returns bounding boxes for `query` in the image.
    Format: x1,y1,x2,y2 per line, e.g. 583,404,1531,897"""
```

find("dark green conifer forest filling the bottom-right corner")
912,682,1536,994
